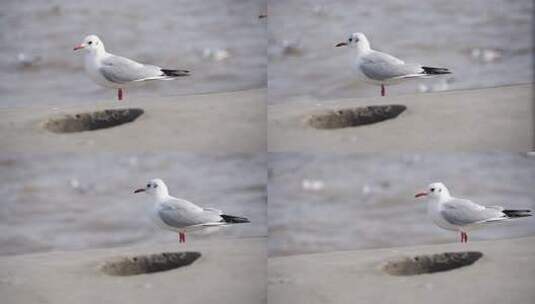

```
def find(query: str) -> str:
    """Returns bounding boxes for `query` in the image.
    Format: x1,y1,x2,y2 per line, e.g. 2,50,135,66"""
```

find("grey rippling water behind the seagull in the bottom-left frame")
0,153,266,255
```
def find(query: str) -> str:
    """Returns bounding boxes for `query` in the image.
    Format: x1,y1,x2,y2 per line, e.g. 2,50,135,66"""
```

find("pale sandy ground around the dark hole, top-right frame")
268,84,534,152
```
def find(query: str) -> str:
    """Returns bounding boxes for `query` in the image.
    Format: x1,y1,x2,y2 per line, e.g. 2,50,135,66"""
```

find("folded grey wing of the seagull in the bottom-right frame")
440,198,506,226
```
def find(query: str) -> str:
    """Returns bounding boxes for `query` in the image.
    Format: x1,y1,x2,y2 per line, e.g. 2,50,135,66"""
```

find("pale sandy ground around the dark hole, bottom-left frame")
0,238,266,304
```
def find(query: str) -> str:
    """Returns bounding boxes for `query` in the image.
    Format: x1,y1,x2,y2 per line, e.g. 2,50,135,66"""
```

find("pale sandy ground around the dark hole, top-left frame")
0,89,266,153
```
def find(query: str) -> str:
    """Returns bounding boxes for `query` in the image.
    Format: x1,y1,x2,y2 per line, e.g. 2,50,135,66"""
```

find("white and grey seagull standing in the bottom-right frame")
415,183,531,243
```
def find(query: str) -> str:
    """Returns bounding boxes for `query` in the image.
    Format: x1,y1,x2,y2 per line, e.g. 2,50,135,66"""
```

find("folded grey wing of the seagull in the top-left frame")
99,54,165,84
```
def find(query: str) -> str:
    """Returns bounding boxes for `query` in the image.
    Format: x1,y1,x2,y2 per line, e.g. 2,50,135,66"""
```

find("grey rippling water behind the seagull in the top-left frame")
0,0,267,107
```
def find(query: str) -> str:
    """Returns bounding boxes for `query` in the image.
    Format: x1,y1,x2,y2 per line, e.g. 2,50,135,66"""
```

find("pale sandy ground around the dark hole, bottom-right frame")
268,237,535,304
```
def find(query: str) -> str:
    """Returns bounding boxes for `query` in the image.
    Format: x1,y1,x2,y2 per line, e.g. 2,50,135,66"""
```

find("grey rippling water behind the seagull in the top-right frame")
268,0,533,103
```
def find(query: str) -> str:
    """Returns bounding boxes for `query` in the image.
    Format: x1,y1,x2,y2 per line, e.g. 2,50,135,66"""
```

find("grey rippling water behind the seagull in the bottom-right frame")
268,153,535,255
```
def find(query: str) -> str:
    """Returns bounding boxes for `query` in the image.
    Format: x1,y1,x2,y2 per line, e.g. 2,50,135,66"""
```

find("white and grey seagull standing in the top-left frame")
74,35,190,100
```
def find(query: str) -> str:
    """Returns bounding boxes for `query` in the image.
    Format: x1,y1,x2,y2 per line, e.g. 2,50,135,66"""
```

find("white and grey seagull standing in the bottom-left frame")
134,178,249,243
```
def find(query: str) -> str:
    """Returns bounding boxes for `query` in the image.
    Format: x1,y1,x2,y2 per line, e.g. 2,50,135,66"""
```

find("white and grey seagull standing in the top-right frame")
336,33,451,96
